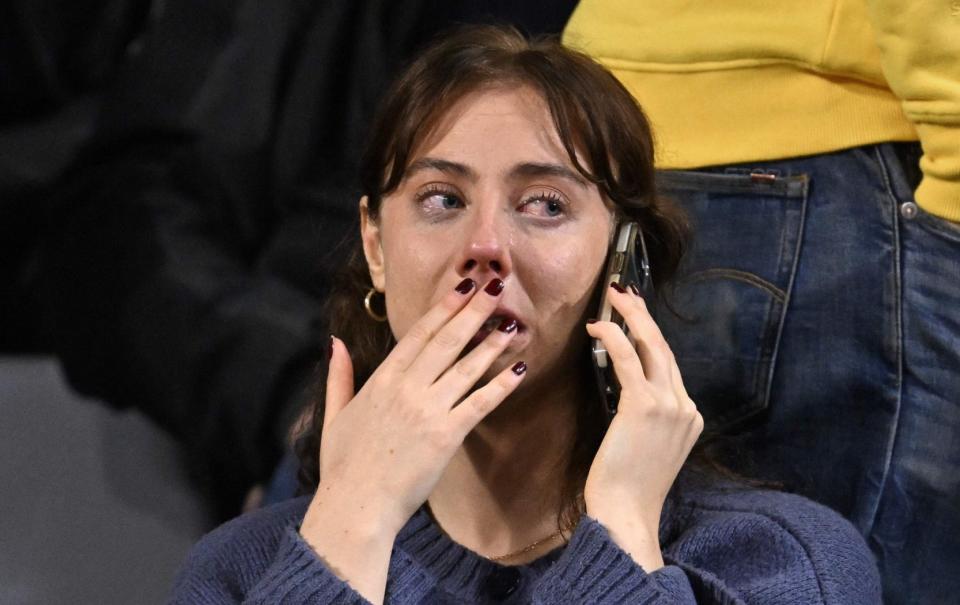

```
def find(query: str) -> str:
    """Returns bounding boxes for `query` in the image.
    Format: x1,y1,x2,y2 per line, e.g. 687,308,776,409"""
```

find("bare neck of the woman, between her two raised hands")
429,370,582,564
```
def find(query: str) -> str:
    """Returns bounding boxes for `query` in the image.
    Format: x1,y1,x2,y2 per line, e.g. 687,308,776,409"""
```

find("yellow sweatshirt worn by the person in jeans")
563,0,960,221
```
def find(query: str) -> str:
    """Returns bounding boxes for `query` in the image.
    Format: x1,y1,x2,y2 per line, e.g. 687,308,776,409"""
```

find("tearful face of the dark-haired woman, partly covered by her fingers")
361,87,613,385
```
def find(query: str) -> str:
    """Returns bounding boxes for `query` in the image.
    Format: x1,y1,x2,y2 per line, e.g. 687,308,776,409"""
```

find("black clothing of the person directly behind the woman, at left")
44,0,575,516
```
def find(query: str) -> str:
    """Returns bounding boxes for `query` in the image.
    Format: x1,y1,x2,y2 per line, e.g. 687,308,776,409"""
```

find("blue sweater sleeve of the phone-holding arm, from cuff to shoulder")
533,490,880,605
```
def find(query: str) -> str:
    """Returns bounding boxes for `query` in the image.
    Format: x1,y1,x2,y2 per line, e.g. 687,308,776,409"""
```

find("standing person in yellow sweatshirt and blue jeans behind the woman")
564,0,960,603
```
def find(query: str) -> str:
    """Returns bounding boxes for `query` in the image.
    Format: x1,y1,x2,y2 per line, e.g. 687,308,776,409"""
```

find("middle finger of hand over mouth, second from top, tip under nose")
407,278,503,384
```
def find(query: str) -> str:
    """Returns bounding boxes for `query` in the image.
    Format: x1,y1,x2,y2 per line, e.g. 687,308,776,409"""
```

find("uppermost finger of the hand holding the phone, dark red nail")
607,286,675,391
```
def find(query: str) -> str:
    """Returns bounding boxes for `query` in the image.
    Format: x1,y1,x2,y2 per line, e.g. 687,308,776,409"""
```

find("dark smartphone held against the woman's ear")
590,222,653,420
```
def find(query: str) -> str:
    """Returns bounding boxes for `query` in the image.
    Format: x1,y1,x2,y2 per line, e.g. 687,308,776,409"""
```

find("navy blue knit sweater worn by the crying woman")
172,489,880,605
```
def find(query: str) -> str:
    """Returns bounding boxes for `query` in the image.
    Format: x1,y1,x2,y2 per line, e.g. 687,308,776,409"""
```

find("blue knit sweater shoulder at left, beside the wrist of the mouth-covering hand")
174,496,310,595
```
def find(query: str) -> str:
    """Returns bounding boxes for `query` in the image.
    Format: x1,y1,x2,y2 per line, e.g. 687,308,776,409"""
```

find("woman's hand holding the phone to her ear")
584,286,703,572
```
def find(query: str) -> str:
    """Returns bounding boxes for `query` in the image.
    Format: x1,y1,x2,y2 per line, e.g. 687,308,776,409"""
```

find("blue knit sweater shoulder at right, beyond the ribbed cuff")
667,486,880,604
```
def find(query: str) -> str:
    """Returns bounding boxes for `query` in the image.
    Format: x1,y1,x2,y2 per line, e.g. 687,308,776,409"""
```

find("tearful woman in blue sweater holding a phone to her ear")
174,27,879,604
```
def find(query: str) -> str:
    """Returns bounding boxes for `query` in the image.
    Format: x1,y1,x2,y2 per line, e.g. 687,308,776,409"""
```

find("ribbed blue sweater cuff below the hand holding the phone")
535,517,696,604
